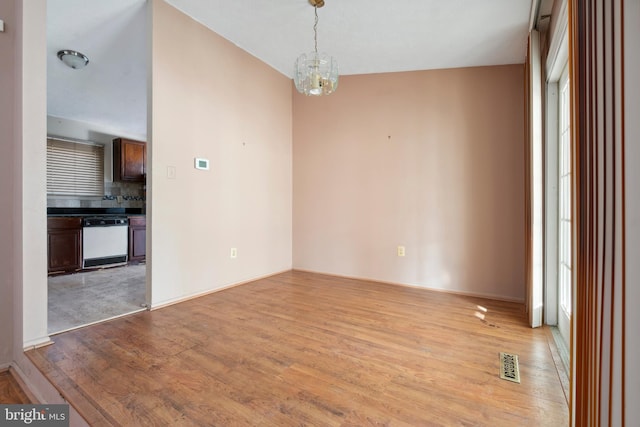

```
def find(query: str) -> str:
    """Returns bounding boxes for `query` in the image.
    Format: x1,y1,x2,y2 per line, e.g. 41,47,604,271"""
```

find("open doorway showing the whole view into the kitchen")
43,0,150,335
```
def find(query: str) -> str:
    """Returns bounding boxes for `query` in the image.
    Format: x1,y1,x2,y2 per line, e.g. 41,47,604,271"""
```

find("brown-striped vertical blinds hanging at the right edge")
569,0,624,426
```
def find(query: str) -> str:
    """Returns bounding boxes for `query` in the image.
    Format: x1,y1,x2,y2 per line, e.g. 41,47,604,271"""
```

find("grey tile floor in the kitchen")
48,264,146,334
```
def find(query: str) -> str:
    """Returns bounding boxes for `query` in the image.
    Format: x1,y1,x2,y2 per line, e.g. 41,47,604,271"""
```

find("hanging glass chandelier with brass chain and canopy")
293,0,338,96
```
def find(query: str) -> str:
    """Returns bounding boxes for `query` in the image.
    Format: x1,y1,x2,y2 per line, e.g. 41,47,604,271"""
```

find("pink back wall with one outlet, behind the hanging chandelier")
293,65,524,300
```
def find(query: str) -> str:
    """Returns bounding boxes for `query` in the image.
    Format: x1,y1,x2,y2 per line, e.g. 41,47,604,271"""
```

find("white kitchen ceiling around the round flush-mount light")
47,0,147,136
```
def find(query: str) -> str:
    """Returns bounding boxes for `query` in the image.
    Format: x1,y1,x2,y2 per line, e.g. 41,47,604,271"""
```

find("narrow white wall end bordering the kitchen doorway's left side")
14,0,49,352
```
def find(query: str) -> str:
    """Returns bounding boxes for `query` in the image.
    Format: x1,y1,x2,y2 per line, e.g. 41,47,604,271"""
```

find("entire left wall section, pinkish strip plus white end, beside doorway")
0,0,49,368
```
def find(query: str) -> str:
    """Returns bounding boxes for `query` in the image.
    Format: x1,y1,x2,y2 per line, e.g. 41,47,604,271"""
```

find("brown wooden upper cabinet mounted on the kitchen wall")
113,138,147,182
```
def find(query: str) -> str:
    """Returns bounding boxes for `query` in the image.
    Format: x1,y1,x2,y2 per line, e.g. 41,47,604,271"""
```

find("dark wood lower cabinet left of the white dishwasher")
47,217,82,274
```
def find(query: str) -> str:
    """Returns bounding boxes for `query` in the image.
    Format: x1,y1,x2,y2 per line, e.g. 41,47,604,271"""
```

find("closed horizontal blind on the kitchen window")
47,138,104,196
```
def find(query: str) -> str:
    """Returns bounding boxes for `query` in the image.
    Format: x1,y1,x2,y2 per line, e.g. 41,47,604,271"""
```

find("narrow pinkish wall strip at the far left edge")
0,0,19,368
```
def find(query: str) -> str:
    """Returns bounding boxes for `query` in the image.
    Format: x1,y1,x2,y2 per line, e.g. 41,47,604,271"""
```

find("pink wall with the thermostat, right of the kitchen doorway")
147,0,292,306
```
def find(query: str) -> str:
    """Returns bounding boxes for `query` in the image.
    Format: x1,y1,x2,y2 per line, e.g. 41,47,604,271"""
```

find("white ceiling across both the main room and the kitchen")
47,0,535,139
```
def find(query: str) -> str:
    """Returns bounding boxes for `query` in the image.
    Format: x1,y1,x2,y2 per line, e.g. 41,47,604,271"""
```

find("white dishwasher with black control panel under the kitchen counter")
82,217,129,268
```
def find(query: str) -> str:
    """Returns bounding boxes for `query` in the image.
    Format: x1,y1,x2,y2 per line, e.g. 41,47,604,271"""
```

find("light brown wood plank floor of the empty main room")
27,271,568,426
